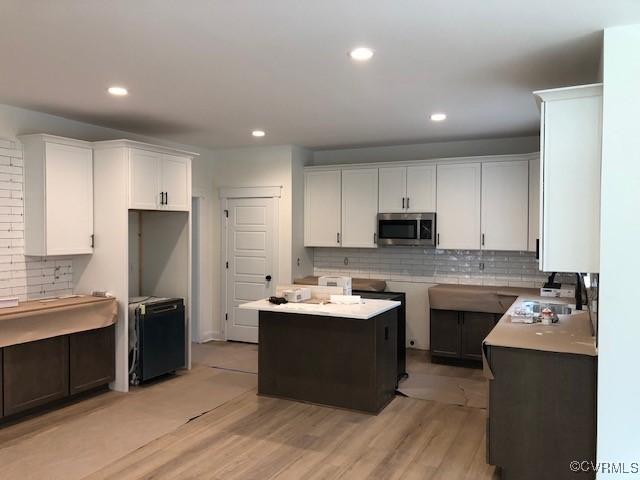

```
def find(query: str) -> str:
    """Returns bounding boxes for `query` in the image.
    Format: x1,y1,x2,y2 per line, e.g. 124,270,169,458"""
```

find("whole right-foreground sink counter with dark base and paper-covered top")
483,296,597,480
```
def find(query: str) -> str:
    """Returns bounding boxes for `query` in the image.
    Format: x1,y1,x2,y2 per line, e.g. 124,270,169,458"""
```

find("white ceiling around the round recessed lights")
0,0,640,148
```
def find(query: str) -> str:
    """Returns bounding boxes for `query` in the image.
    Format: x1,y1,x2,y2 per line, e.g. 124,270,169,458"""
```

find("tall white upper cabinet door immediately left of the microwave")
341,168,378,248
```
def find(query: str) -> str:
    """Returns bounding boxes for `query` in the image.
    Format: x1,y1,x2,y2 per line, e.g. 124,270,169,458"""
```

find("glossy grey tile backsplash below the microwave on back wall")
313,247,548,288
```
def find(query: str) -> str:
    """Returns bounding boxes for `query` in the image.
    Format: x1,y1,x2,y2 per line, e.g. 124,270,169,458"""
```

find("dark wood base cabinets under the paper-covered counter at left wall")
0,325,115,417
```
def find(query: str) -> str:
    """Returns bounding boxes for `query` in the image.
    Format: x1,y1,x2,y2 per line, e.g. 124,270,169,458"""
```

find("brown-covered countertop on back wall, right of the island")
429,284,540,314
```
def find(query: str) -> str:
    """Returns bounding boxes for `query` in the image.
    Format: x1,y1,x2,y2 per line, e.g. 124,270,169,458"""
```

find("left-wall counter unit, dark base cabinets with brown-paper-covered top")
0,297,117,423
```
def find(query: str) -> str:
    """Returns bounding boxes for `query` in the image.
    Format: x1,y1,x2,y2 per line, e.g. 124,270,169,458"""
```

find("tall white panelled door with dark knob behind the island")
224,198,276,343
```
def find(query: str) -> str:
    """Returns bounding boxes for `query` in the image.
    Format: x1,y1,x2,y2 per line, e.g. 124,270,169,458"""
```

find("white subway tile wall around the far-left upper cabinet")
0,139,73,300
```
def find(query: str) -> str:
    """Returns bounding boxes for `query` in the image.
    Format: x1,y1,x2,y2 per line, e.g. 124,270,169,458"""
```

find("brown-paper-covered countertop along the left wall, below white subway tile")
0,295,118,347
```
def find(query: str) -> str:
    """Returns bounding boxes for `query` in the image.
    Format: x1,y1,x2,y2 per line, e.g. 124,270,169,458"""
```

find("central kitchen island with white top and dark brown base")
240,299,400,414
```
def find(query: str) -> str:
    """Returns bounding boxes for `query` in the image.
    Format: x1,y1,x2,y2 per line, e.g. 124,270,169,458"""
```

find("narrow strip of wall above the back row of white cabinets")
313,135,540,165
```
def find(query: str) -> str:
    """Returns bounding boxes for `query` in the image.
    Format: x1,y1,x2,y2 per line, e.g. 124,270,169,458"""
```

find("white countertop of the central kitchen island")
239,299,400,320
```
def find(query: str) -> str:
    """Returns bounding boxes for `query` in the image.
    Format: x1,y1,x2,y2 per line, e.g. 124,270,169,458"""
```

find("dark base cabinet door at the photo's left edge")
2,336,69,416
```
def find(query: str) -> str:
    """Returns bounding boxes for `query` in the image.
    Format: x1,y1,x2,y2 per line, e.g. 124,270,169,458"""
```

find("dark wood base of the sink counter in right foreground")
487,346,597,480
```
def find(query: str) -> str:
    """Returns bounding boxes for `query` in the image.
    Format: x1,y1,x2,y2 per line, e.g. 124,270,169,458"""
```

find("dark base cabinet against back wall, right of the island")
430,309,499,361
